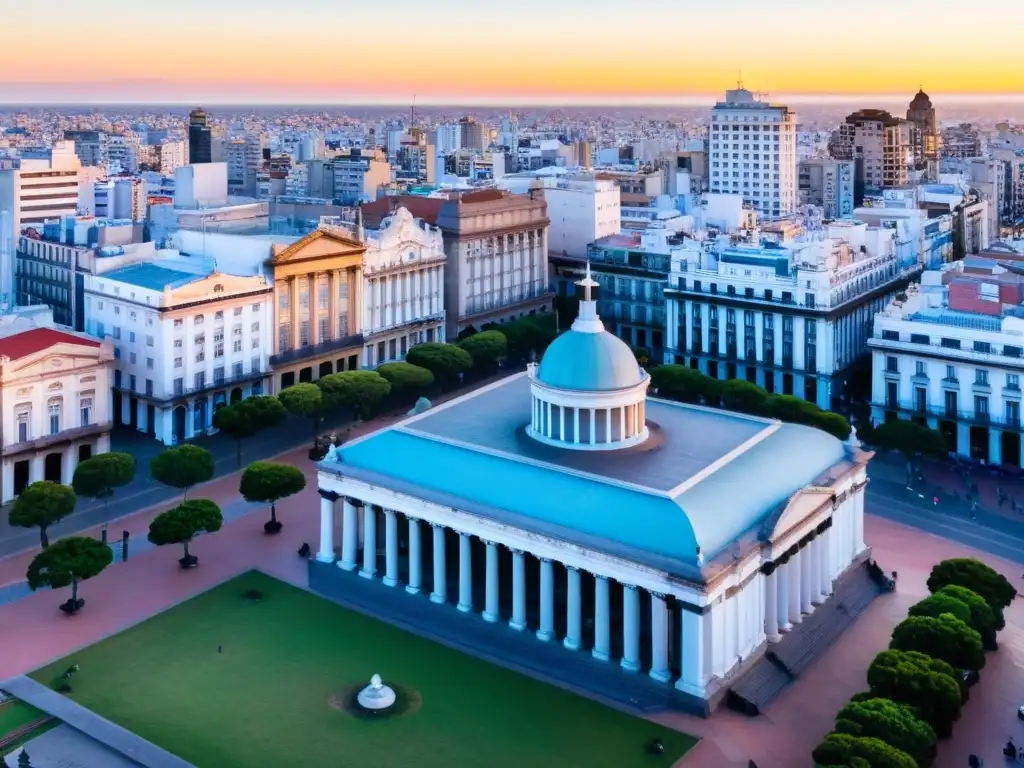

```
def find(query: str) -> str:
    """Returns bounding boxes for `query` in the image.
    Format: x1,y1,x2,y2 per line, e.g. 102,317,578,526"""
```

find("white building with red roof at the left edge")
0,315,114,504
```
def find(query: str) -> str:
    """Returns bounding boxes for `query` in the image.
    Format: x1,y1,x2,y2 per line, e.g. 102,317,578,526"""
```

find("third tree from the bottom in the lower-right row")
867,650,964,738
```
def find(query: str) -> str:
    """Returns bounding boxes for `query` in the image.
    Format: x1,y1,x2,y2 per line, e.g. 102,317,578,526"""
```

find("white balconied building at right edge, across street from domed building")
869,270,1024,467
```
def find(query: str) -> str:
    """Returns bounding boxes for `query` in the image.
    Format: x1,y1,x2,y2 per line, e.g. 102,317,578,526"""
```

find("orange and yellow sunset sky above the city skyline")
0,0,1024,103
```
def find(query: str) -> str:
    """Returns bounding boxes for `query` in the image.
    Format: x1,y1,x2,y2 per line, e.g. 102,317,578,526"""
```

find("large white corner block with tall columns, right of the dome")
665,221,921,409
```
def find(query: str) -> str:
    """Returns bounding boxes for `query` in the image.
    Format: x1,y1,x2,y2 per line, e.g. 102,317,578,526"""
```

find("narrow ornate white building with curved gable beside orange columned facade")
361,208,446,368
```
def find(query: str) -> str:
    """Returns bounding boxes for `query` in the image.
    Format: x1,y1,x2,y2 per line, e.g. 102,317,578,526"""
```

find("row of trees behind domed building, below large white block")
650,365,850,440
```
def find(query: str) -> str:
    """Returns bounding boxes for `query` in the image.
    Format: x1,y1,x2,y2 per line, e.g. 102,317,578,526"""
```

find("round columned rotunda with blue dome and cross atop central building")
526,264,650,451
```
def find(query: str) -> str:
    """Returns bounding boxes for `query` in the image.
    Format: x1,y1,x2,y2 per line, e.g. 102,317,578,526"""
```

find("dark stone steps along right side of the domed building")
726,561,883,717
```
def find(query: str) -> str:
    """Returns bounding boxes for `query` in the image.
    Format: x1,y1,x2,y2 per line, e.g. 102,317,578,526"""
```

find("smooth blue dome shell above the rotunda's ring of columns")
537,331,644,392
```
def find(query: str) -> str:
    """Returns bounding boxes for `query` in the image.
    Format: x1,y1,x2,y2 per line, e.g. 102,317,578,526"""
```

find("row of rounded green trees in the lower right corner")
813,558,1017,768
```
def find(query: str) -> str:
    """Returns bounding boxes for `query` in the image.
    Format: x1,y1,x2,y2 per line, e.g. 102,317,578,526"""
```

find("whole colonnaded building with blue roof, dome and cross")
309,267,870,714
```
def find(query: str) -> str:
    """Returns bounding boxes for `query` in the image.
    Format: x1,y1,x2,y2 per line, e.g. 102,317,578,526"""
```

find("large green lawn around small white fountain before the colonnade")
32,572,694,768
